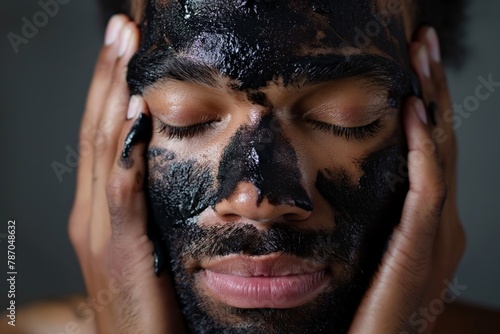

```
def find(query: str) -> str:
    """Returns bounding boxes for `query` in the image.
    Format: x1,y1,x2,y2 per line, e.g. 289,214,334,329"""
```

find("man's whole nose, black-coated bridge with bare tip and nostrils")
214,114,312,226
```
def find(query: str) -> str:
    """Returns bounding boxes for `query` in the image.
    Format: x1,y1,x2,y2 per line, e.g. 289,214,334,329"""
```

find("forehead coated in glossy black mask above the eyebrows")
129,0,406,93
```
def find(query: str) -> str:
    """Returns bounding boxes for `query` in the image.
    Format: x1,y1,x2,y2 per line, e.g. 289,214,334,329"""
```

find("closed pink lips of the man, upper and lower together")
197,253,330,308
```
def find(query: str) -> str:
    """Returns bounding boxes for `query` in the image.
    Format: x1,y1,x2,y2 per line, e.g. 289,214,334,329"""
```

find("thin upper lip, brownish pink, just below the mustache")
200,253,325,277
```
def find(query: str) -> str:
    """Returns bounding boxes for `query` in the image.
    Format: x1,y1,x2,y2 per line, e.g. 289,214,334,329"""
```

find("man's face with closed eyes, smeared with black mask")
129,0,410,333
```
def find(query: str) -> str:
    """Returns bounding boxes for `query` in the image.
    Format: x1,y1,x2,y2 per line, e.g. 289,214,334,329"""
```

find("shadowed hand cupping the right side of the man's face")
350,27,465,334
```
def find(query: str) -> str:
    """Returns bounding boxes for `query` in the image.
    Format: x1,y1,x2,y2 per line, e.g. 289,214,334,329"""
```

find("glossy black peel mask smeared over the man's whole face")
128,0,410,333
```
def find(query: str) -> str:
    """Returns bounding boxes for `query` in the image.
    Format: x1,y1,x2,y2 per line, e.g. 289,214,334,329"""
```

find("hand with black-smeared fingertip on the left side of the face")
69,15,183,334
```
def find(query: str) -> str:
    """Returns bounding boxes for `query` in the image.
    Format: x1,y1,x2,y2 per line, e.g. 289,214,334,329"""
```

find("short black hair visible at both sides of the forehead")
98,0,469,68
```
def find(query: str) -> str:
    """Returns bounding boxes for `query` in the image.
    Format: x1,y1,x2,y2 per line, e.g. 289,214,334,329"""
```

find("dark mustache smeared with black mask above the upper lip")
169,223,356,263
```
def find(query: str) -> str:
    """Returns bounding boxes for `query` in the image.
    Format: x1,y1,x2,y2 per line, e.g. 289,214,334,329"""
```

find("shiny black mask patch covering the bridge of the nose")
217,113,312,211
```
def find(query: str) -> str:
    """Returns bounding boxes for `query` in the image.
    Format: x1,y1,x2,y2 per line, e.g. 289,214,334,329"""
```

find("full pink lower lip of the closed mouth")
199,269,328,308
